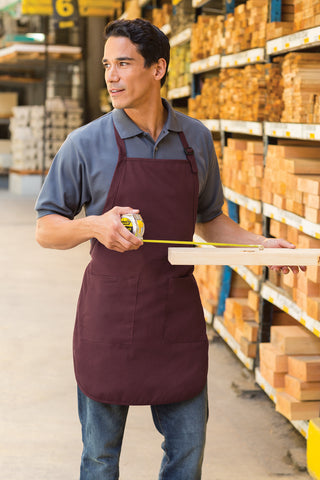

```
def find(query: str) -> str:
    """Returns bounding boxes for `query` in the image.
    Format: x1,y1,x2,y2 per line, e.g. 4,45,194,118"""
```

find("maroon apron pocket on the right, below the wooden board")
164,276,206,343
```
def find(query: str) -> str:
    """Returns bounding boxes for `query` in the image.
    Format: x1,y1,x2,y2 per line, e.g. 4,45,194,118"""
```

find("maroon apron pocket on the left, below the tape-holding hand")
77,271,138,344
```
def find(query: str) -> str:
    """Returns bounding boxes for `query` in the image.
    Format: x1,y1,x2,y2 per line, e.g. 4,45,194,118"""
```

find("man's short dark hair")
104,18,170,86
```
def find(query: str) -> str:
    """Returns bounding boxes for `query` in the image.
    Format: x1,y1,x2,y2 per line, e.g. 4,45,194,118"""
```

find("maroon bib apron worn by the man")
74,121,208,405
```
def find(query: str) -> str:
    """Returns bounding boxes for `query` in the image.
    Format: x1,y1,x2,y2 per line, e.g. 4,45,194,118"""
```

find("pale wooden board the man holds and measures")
168,247,320,265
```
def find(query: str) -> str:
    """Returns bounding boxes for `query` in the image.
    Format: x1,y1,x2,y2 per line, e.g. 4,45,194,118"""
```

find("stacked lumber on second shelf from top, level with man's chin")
220,62,283,122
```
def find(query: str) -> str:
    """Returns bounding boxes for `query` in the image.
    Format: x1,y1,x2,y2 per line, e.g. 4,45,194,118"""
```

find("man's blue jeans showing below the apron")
78,388,208,480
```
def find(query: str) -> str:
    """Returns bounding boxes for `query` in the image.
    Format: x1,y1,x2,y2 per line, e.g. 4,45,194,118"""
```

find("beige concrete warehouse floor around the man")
0,190,310,480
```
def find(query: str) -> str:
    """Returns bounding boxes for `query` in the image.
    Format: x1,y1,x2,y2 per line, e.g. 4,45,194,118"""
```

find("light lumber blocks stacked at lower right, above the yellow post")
259,325,320,420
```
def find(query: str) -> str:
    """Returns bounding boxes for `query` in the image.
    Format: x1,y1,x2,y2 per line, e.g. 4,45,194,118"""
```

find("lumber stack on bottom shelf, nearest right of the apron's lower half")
223,290,259,358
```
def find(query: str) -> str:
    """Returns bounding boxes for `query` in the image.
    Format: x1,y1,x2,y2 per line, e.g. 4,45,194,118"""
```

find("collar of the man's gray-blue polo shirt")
112,98,182,139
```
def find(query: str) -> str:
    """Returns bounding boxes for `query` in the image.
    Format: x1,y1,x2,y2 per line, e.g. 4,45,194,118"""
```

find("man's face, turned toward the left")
102,37,157,109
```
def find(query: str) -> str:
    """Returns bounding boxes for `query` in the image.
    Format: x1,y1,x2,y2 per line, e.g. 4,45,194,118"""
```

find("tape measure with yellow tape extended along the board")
121,213,264,250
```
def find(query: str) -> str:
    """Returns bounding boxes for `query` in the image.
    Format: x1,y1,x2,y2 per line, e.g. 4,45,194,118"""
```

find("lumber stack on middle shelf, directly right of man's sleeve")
222,138,263,200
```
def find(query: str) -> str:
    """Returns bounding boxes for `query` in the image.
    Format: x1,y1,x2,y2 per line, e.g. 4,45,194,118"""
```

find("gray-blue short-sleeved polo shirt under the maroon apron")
36,100,224,222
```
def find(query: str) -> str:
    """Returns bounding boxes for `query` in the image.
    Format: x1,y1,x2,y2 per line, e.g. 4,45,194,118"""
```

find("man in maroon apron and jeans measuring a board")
37,19,297,480
